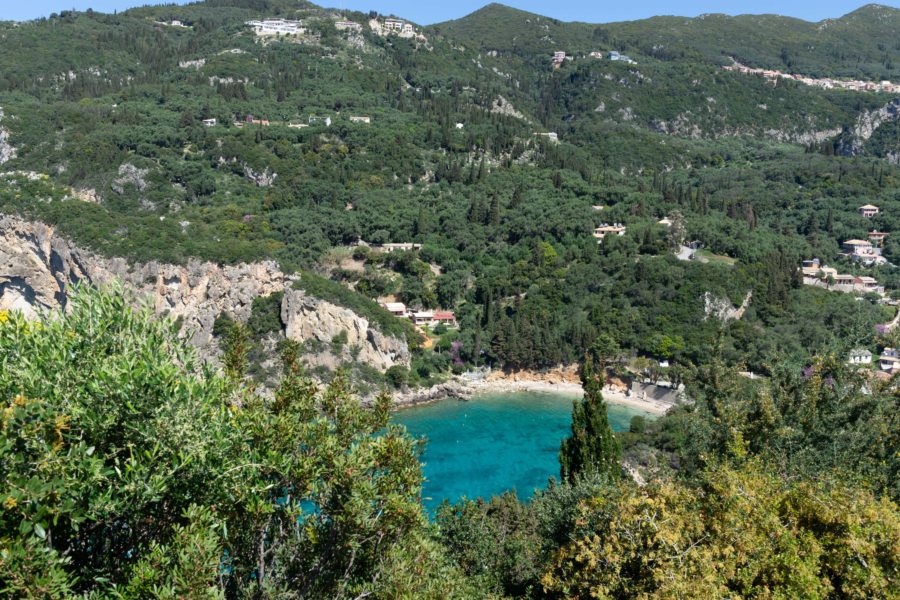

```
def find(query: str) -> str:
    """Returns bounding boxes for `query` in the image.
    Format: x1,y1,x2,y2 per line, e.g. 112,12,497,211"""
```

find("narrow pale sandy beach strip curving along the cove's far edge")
394,378,673,417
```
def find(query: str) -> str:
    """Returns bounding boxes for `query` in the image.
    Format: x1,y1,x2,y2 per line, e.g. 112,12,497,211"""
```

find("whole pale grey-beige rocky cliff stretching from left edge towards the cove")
0,215,409,370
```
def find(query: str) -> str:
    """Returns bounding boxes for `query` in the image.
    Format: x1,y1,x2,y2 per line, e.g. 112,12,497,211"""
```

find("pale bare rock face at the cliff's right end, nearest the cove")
281,289,409,371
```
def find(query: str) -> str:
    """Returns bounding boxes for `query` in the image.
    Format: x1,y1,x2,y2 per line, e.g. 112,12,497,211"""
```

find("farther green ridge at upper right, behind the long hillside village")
432,4,900,80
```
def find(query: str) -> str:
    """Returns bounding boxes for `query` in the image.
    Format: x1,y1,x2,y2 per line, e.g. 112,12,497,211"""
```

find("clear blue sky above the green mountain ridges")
7,0,900,24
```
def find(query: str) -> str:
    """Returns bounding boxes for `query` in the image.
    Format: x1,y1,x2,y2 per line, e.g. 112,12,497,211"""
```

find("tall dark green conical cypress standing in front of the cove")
559,356,621,482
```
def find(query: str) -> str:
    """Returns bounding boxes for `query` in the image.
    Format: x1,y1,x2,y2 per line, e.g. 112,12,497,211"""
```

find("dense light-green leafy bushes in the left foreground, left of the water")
0,290,478,598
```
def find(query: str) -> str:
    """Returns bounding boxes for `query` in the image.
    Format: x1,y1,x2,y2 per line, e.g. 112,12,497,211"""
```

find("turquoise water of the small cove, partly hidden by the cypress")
393,392,652,511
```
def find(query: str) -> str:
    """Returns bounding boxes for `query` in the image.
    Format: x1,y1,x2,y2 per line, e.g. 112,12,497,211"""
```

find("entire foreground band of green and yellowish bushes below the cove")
0,289,900,598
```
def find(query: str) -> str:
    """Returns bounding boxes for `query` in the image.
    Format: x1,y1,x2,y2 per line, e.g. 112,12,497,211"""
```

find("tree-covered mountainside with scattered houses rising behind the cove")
0,0,900,384
